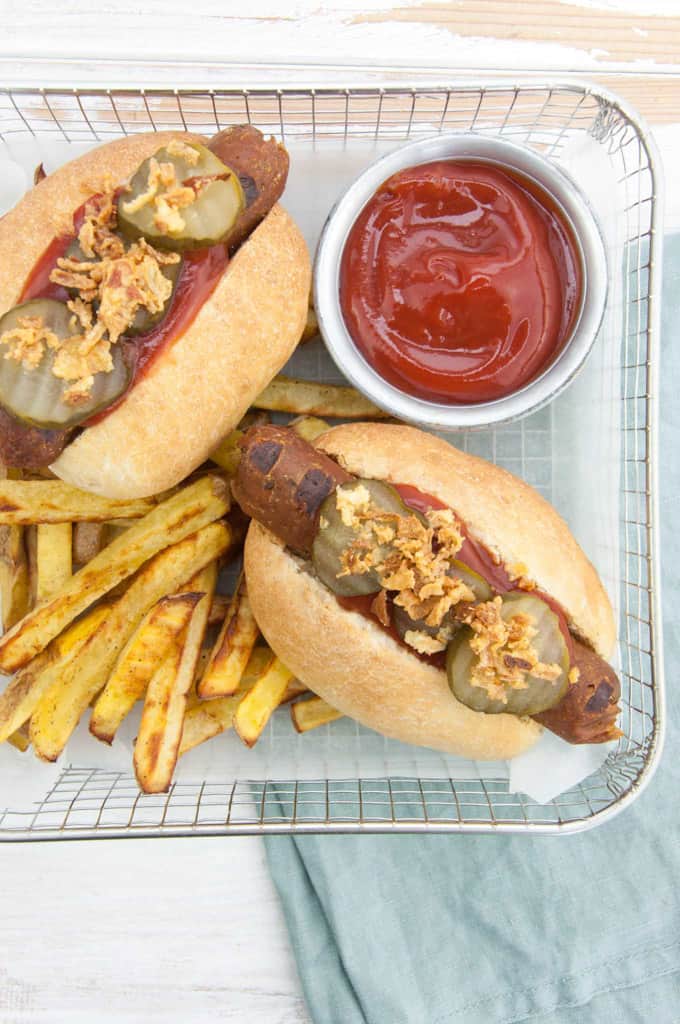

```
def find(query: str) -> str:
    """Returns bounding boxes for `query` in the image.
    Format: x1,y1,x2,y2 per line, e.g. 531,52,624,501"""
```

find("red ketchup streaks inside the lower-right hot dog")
337,483,573,669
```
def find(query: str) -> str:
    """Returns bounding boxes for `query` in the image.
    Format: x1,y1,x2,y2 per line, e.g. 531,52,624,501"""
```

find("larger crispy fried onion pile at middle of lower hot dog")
336,485,474,654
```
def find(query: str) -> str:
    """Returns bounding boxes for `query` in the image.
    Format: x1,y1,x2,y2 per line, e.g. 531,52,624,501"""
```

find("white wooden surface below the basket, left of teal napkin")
0,839,310,1024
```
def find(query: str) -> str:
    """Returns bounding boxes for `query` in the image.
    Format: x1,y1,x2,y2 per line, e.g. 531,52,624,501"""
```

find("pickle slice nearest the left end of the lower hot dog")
311,479,410,597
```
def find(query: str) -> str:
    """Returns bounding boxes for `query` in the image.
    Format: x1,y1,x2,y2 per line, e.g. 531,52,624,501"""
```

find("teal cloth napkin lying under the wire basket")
266,236,680,1024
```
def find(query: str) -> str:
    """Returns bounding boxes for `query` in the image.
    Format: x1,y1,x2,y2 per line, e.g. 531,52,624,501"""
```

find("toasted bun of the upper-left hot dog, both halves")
0,132,310,498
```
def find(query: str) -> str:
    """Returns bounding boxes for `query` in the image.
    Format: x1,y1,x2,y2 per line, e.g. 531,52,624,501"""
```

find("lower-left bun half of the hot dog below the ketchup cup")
246,522,542,761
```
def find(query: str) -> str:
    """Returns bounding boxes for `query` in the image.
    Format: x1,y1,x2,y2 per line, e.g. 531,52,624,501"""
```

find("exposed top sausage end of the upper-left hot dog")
208,125,290,250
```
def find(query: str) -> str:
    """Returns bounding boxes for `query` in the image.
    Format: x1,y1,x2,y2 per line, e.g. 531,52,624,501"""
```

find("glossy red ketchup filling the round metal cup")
340,160,582,404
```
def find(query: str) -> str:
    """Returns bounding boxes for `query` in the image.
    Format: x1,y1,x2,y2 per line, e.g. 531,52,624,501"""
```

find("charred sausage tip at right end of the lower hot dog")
534,640,621,743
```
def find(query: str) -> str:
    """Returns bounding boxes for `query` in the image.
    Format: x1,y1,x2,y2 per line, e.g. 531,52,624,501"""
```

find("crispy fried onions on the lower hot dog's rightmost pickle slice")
463,597,562,703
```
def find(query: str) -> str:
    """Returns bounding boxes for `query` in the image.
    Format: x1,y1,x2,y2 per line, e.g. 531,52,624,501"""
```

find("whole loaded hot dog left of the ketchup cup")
0,126,310,498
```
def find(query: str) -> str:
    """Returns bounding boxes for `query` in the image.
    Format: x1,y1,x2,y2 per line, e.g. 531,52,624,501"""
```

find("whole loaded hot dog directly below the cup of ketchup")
232,424,621,760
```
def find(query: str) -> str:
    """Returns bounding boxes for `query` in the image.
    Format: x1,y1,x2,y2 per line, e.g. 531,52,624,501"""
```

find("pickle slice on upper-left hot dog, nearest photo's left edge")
0,299,130,429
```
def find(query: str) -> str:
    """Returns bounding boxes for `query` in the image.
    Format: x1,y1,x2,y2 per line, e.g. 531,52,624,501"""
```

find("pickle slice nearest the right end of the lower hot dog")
447,594,569,715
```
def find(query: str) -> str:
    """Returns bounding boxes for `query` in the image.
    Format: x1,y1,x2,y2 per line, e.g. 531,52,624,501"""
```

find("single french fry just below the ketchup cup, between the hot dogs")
253,374,390,420
